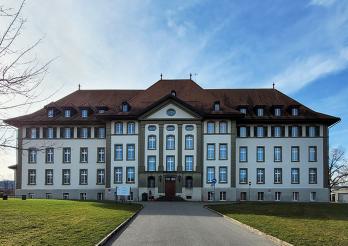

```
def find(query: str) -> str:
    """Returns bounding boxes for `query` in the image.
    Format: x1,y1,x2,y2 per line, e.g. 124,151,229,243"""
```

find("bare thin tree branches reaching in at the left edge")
0,0,51,148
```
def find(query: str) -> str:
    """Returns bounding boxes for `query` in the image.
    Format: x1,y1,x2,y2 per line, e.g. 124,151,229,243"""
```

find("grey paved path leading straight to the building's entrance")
109,202,275,246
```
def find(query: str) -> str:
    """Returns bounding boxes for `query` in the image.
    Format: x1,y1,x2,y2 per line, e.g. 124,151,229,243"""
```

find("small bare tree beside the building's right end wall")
329,148,348,191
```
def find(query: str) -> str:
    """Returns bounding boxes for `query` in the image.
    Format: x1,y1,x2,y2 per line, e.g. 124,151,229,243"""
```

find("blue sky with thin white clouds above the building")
0,0,348,180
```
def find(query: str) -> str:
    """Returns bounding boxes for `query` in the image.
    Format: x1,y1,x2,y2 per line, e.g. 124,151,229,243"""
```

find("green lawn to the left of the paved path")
0,199,140,245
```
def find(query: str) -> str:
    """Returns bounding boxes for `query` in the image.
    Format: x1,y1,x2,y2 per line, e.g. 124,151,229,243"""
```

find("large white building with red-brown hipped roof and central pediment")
6,79,339,202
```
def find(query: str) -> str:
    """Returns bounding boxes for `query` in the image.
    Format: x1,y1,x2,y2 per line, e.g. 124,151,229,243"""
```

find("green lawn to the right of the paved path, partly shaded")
209,203,348,246
